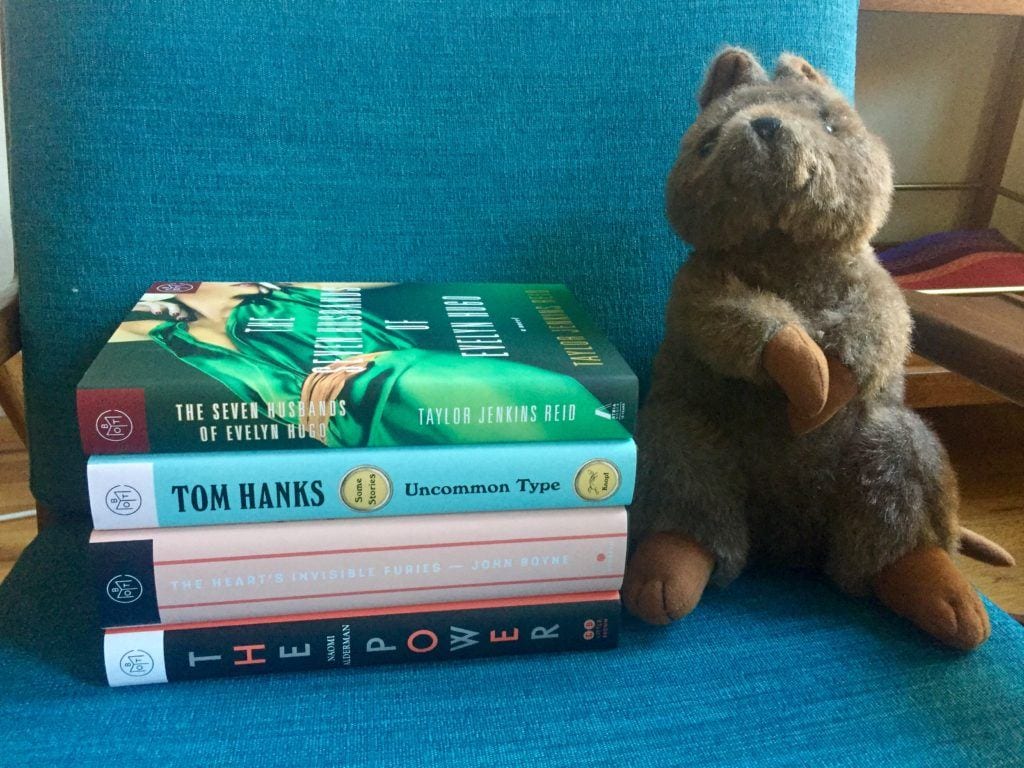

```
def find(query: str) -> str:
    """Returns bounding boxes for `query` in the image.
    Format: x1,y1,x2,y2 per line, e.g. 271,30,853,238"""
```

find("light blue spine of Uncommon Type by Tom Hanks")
88,439,636,530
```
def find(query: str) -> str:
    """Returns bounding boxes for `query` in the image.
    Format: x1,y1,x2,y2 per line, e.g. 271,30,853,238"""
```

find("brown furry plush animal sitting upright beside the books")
623,48,1009,649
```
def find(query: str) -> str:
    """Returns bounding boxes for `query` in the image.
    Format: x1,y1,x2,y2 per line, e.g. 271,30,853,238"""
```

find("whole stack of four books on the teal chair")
78,282,638,685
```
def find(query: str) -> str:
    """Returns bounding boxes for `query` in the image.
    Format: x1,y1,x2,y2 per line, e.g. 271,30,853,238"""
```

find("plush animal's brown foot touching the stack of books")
623,532,715,625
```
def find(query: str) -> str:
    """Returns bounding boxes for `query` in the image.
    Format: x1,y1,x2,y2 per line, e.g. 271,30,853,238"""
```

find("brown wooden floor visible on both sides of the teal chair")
0,404,1024,613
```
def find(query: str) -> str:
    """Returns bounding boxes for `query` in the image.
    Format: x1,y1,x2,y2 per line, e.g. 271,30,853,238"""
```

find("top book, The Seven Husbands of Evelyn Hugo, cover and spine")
77,282,638,455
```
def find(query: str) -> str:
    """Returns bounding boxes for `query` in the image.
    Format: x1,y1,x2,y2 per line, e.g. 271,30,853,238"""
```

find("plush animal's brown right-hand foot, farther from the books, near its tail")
874,547,992,650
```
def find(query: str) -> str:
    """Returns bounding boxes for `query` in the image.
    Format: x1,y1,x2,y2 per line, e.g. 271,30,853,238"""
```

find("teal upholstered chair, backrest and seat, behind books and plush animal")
0,0,1024,766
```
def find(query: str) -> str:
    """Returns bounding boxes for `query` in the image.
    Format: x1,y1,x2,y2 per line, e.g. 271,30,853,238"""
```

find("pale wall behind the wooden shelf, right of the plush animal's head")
856,11,1024,242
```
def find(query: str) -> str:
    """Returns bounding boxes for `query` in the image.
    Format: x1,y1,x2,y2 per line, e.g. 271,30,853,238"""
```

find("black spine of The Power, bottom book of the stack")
103,593,621,686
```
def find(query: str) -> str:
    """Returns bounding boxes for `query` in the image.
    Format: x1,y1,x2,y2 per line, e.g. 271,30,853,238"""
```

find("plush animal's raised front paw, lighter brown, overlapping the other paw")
761,323,828,419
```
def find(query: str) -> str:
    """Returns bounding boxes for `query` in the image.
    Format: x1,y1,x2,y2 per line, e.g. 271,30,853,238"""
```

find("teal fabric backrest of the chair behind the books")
4,0,857,517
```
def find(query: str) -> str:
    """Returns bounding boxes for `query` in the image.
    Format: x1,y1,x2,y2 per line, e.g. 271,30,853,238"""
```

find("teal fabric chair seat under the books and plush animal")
6,530,1024,768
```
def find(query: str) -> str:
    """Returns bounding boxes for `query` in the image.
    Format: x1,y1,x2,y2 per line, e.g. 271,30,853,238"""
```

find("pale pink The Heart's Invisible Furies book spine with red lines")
89,507,626,627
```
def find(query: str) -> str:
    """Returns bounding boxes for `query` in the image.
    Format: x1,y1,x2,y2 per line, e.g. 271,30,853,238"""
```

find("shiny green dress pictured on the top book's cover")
143,286,629,446
